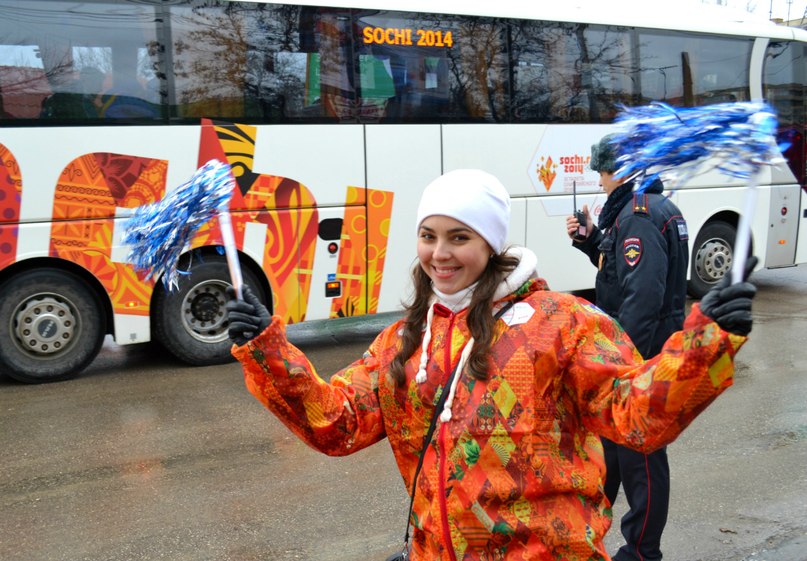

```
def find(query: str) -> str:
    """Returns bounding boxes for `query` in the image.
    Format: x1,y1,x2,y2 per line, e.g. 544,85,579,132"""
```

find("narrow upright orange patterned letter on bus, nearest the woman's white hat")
330,187,393,317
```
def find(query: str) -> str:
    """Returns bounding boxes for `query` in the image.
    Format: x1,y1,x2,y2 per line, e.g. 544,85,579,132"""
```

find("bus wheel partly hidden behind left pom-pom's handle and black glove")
152,255,263,366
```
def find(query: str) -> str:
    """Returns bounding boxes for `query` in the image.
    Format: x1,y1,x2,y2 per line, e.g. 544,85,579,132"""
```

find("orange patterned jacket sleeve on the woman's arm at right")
565,304,747,452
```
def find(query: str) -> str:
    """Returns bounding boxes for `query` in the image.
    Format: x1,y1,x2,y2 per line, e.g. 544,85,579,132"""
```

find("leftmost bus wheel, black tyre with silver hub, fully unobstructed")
0,269,106,383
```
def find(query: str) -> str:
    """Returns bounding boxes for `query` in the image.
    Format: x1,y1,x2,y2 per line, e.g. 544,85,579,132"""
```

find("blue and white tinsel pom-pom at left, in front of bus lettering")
122,160,240,290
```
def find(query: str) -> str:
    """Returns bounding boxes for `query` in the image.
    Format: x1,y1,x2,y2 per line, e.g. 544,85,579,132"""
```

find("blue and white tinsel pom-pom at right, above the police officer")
612,102,784,192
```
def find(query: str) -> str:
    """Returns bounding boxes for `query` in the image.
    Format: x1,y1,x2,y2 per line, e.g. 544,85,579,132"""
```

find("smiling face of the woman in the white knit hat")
418,215,493,294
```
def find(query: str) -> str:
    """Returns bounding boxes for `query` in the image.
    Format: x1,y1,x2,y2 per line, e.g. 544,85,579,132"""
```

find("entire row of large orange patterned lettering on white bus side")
38,119,393,323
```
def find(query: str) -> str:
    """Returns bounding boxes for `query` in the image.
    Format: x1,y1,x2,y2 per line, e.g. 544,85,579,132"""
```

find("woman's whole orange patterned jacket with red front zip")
233,279,746,561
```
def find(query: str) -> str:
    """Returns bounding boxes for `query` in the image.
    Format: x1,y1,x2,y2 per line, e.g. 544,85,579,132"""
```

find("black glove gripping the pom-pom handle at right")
701,256,758,335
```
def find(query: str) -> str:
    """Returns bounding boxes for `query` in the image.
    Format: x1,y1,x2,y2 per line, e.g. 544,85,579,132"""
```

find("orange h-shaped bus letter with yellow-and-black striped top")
197,119,319,323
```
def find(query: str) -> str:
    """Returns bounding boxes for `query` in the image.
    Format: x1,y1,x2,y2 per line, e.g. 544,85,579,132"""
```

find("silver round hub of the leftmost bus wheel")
13,294,76,355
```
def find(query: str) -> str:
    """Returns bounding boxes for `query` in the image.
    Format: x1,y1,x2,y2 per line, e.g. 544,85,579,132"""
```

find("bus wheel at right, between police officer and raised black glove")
688,220,737,298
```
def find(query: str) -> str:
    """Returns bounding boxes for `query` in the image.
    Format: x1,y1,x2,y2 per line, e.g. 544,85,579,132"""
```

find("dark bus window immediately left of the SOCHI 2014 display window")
171,2,355,122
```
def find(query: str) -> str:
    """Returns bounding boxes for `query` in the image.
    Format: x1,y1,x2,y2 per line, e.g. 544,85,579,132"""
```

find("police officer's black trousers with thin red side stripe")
602,438,670,561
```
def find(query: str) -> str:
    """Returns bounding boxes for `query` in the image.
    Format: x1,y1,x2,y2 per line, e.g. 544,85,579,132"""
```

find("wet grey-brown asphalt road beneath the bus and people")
0,266,807,561
